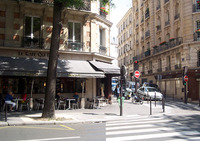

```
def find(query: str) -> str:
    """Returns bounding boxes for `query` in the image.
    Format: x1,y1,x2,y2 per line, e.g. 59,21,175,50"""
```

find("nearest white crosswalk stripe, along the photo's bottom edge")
106,131,200,141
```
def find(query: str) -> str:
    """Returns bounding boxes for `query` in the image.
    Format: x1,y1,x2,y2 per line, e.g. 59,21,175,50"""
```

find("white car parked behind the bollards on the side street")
137,87,163,100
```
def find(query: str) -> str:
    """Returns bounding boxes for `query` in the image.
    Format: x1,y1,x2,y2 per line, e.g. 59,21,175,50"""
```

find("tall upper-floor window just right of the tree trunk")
68,22,81,42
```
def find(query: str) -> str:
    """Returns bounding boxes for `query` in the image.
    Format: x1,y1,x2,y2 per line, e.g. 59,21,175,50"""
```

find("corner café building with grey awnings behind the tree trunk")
0,0,119,103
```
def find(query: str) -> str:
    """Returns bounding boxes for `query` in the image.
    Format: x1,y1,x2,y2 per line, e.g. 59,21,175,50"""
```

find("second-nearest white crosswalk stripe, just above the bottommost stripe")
106,127,190,135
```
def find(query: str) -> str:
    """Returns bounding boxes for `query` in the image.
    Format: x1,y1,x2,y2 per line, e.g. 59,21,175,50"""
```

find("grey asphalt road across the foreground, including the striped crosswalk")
0,114,200,141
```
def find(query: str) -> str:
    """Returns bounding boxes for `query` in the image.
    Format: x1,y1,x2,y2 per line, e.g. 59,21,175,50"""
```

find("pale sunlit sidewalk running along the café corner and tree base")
0,100,200,126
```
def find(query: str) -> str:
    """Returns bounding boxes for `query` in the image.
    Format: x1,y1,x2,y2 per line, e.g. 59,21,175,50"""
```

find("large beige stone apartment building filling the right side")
118,0,200,100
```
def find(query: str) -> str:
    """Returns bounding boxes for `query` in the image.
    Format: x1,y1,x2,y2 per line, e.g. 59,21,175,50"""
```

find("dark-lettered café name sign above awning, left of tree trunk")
18,51,49,58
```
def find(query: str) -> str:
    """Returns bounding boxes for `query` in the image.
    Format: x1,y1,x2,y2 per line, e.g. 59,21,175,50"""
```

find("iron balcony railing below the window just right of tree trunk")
67,41,84,51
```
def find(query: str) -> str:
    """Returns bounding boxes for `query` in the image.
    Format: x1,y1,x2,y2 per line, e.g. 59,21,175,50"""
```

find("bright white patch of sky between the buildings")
110,0,132,37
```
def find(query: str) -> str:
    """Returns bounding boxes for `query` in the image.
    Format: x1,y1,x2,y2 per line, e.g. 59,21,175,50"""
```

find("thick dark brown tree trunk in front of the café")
42,1,64,118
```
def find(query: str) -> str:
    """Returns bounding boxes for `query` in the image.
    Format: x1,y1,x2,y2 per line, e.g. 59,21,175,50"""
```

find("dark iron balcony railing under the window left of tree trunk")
22,37,44,49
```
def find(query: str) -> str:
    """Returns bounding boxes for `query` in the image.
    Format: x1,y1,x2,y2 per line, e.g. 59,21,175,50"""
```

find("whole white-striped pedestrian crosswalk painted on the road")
106,117,200,141
